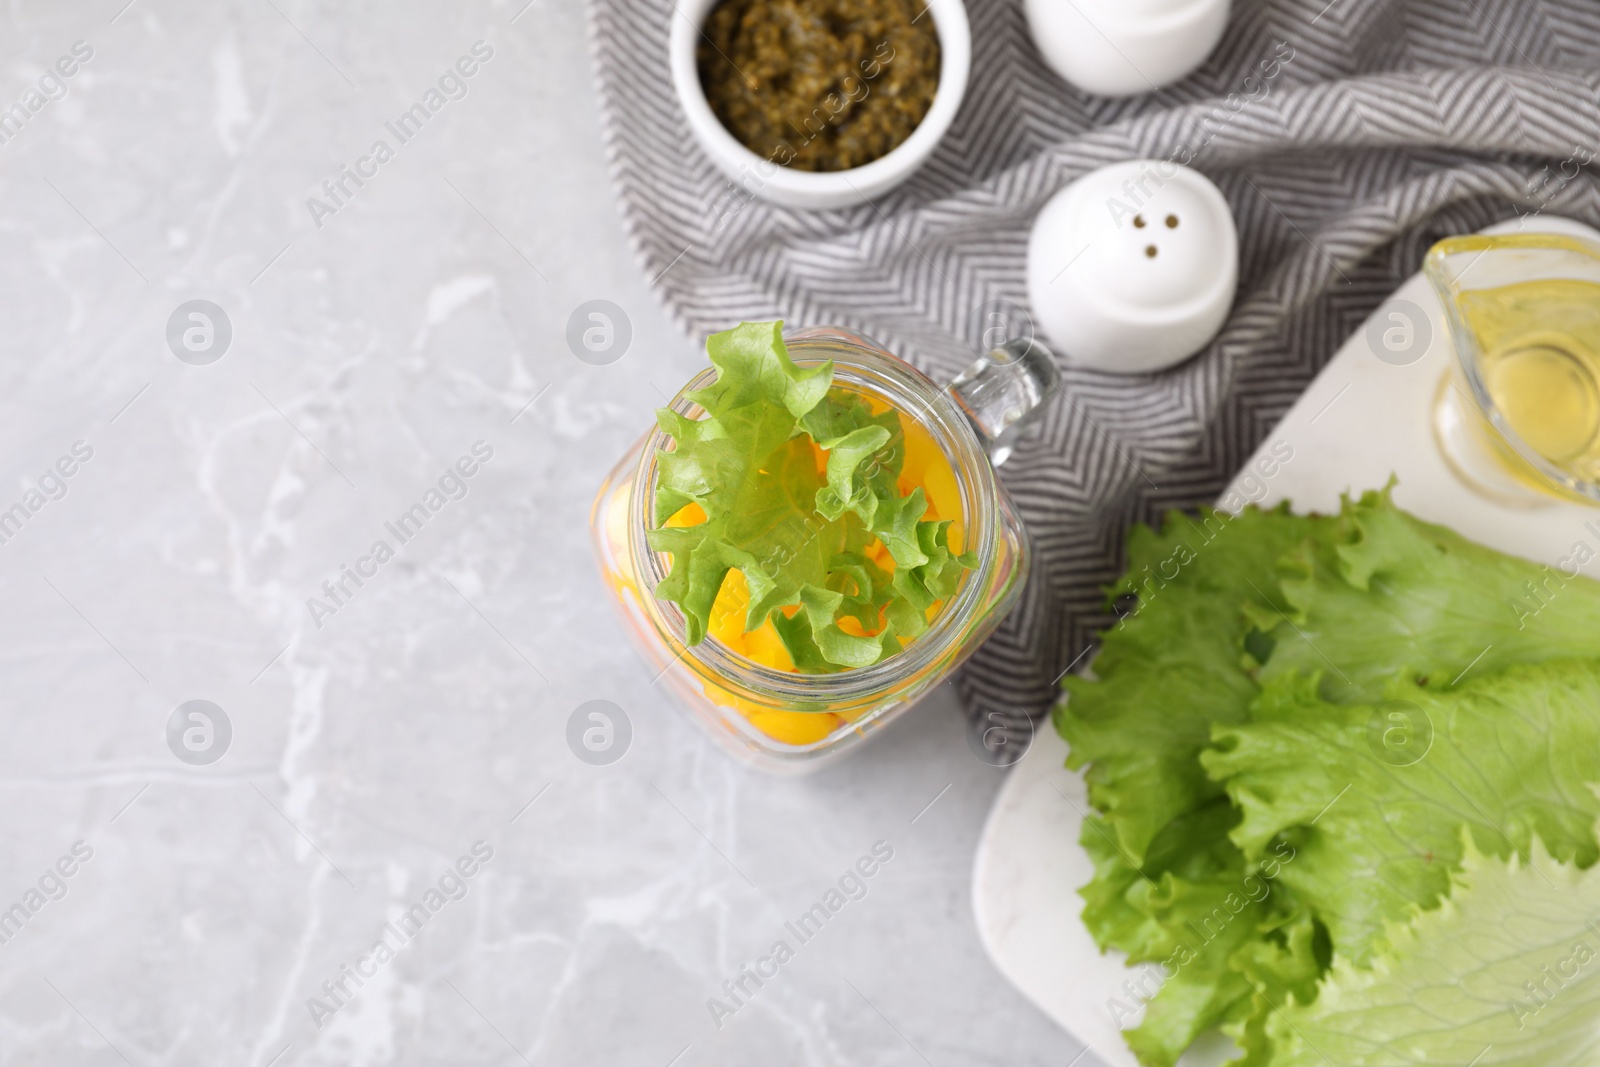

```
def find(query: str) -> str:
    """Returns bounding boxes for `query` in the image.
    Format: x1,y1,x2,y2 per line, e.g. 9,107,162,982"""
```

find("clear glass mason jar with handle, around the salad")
590,326,1058,773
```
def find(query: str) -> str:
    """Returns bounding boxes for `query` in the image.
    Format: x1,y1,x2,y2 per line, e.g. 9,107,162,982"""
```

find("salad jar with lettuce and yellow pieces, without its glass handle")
594,323,1027,769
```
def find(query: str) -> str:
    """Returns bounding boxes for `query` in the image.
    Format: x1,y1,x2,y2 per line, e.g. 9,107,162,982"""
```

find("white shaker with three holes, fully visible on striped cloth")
1027,160,1238,374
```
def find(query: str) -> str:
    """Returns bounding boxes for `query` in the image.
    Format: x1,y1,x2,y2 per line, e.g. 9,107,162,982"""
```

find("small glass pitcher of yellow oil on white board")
1422,234,1600,507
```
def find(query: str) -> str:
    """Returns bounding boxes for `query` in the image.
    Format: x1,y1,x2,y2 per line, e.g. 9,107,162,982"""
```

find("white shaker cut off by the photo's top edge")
1024,0,1229,96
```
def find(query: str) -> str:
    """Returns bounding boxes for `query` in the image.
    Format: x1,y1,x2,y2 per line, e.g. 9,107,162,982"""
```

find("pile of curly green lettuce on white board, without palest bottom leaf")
1056,491,1600,1067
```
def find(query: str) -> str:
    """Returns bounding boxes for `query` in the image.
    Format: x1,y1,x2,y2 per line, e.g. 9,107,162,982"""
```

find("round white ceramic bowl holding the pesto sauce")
667,0,973,208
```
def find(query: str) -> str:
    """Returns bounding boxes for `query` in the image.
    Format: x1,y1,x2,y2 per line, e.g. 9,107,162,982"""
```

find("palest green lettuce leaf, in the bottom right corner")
1267,827,1600,1067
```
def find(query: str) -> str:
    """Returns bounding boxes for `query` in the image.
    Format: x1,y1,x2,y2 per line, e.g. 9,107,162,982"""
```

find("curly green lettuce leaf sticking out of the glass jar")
646,322,976,673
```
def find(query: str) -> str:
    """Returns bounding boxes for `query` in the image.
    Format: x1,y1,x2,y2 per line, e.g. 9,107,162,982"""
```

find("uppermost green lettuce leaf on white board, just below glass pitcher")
1256,485,1600,701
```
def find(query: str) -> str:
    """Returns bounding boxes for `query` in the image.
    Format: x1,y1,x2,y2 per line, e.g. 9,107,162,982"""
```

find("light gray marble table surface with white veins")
0,0,1093,1067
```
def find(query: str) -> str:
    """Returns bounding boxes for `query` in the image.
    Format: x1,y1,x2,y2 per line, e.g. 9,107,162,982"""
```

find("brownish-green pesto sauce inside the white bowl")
696,0,939,171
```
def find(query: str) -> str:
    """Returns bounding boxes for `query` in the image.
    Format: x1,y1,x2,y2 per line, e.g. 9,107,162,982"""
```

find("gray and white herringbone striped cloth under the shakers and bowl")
589,0,1600,742
